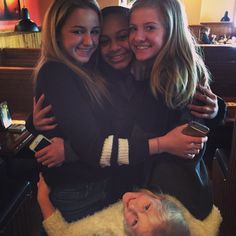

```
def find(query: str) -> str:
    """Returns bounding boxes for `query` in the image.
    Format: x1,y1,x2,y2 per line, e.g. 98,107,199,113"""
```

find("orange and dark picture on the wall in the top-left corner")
0,0,20,20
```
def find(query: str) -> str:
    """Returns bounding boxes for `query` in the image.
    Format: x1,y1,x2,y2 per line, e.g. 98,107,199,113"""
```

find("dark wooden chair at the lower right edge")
212,113,236,236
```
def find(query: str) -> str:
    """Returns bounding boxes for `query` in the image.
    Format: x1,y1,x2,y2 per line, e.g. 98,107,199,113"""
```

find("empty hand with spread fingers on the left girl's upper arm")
33,94,57,131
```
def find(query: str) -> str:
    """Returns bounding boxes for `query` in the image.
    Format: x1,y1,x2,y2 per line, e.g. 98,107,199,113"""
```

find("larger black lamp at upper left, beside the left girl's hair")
15,7,39,32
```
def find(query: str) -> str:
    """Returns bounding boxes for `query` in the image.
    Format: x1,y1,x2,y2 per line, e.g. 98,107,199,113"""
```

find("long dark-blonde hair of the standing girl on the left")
35,0,106,104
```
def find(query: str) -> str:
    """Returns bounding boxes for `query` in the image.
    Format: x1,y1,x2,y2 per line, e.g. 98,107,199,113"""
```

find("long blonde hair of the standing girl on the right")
131,0,210,108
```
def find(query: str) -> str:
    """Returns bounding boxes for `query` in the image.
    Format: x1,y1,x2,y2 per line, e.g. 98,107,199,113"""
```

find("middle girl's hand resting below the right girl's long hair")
188,85,219,119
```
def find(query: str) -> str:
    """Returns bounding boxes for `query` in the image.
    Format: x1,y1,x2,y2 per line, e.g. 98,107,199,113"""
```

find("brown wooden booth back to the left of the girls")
0,48,40,114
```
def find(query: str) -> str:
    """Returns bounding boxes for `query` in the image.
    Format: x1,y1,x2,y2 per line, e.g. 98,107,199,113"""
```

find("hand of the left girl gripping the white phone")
35,137,65,168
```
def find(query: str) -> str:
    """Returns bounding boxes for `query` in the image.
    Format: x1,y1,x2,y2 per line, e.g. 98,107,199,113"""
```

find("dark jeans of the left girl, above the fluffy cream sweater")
50,180,110,222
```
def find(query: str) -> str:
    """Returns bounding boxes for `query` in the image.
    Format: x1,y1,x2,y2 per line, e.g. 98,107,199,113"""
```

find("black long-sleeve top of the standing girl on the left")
30,61,116,188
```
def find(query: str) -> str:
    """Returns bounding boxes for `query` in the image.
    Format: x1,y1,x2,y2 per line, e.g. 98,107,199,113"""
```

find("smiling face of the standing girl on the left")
60,8,100,64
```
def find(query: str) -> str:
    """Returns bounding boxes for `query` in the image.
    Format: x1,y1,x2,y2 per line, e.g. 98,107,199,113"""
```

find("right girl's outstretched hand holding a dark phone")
159,124,207,159
